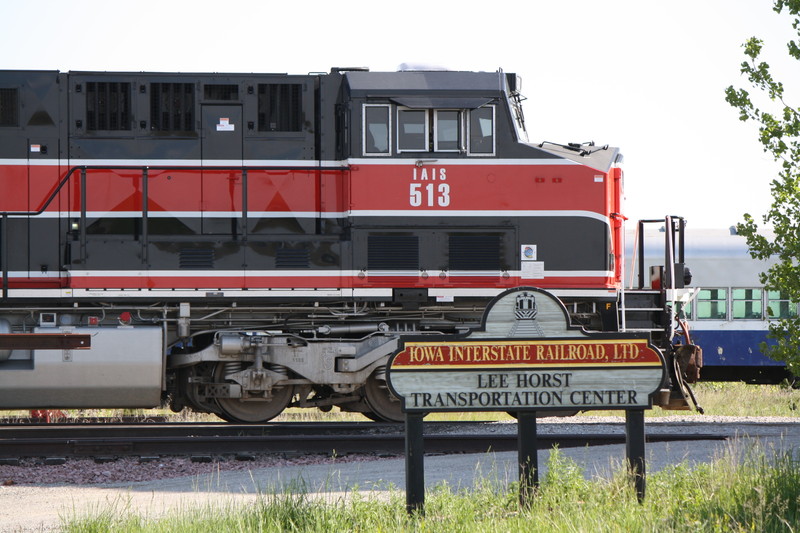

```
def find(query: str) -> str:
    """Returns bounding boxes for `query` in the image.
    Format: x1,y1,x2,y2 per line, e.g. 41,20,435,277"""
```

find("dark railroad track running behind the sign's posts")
0,422,726,464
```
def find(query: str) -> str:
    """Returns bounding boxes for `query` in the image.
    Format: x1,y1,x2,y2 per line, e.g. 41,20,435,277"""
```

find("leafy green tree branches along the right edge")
725,0,800,376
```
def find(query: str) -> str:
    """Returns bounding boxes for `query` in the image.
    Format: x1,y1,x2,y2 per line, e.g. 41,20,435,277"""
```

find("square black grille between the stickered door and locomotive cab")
258,83,303,131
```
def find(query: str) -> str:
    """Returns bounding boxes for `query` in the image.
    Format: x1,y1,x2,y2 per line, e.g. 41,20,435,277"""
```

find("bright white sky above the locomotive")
0,0,800,228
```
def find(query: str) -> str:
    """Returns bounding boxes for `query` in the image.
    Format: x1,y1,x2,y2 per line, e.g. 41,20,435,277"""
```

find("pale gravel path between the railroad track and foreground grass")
0,416,800,532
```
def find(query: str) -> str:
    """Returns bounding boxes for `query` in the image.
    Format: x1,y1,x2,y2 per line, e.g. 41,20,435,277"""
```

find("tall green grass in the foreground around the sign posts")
62,447,800,533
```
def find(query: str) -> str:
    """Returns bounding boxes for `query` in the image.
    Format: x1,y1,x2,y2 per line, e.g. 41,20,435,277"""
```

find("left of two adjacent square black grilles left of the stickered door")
86,81,131,131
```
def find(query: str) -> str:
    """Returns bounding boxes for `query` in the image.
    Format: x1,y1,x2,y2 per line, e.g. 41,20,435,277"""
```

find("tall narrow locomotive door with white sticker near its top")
199,105,246,287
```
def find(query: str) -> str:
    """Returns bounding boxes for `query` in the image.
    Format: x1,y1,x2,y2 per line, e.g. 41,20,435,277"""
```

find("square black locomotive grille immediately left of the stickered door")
150,83,195,133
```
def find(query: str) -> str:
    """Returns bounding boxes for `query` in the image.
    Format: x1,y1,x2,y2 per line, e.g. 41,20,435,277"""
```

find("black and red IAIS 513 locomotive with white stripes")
0,68,696,423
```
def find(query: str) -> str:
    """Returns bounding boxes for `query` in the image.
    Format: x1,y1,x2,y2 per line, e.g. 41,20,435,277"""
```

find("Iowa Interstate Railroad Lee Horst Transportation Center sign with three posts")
387,287,666,512
